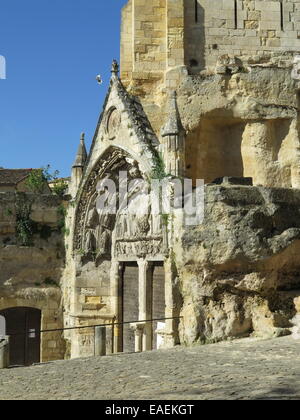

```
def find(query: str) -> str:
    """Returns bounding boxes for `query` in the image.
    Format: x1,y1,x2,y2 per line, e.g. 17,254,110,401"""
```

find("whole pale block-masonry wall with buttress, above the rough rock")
121,0,300,82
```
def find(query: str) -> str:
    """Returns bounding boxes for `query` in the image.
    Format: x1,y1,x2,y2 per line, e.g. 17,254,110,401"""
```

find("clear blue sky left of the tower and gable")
0,0,127,176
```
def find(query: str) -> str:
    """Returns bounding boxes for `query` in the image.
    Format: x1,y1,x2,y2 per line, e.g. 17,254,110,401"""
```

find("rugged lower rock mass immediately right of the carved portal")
175,186,300,343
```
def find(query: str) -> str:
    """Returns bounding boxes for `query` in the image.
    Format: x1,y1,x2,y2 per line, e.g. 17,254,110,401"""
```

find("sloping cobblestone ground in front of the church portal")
0,337,300,400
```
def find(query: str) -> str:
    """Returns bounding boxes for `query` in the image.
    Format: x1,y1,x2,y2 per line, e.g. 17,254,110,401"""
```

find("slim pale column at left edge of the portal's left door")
110,261,122,353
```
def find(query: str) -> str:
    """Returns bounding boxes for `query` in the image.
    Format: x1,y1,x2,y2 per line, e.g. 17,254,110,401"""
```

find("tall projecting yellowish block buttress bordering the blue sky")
121,0,184,96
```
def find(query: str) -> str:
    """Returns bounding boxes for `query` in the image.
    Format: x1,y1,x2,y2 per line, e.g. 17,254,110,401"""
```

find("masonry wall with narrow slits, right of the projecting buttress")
185,0,300,69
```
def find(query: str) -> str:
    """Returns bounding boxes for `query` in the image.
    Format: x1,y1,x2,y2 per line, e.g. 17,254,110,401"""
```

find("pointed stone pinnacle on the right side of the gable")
161,91,185,176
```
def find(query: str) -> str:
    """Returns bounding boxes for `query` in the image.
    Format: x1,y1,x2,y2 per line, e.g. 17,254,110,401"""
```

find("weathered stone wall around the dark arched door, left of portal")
0,193,65,362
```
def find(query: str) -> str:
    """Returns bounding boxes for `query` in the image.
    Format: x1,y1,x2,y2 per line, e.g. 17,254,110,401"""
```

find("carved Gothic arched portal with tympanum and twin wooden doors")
72,147,168,357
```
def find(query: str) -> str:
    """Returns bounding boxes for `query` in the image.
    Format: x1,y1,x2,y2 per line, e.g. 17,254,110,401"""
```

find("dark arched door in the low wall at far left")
0,307,41,366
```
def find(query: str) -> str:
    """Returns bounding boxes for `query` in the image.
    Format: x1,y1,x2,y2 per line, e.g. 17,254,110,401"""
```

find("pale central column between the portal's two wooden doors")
138,260,152,350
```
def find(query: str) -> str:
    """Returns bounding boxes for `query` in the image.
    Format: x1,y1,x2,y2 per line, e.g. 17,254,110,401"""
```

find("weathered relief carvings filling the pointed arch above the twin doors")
74,149,164,262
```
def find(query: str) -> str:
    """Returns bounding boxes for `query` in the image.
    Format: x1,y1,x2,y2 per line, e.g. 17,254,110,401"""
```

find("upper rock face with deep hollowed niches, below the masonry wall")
177,65,300,188
